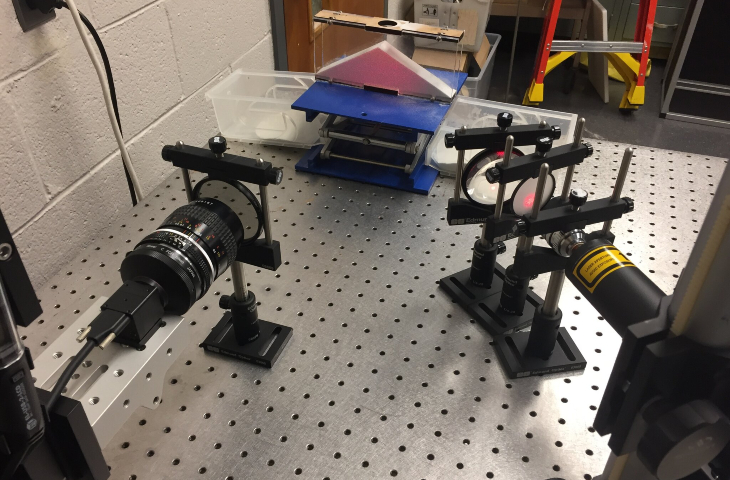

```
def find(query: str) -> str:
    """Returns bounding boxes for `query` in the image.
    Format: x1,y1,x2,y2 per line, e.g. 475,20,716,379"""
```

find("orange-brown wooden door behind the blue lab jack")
284,0,387,72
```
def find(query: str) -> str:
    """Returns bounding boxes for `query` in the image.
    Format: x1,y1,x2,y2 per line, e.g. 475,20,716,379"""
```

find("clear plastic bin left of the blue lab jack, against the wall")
205,70,324,147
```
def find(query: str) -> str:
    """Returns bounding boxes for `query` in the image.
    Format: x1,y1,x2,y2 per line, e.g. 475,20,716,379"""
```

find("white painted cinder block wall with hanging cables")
0,0,274,287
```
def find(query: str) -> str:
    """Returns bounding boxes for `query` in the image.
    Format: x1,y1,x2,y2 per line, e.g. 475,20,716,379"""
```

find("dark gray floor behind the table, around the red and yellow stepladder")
489,32,730,158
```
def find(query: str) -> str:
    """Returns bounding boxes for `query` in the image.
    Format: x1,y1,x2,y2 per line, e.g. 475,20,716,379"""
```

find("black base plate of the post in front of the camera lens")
201,312,294,368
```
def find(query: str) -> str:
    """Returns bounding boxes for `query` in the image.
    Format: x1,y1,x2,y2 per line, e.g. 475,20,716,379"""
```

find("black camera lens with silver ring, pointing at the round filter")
120,198,243,315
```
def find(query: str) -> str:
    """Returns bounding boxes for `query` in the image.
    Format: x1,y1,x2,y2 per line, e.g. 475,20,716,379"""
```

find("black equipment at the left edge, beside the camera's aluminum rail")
0,207,109,480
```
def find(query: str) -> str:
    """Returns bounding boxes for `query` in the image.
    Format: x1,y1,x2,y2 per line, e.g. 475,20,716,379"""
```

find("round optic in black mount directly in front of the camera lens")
193,177,264,245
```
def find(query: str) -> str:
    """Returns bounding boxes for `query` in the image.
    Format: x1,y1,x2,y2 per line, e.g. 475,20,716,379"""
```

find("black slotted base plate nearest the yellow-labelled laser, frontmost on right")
494,327,586,378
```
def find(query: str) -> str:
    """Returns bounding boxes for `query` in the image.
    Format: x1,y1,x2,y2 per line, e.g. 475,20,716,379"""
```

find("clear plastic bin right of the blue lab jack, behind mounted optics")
426,95,578,177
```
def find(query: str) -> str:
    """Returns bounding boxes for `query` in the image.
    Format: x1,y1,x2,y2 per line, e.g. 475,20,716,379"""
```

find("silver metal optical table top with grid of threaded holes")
21,140,726,480
